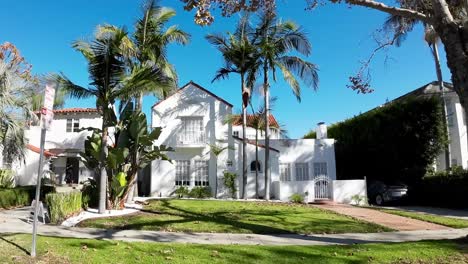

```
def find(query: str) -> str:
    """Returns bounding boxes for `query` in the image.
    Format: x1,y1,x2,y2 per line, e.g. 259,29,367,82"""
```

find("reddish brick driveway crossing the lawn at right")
313,204,450,231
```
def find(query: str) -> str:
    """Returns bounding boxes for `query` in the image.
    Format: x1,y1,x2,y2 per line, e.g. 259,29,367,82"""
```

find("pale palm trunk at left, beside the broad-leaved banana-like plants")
98,123,109,214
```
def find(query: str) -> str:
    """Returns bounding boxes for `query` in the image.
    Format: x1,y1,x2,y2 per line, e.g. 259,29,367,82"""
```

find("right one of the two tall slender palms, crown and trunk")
255,12,318,200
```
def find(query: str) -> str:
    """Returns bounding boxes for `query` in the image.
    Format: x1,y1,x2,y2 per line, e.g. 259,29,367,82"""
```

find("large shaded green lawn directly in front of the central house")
79,200,389,234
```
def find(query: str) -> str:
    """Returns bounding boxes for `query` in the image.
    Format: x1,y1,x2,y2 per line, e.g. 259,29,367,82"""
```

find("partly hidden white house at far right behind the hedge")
394,81,468,171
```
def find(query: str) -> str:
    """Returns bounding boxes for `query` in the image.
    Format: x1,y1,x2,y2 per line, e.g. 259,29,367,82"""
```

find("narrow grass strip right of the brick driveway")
372,207,468,228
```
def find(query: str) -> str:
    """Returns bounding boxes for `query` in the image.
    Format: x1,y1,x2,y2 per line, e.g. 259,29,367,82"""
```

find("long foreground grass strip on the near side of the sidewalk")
0,235,468,264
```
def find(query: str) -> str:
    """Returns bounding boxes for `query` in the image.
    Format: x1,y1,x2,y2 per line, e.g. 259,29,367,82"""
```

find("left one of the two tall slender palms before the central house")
206,15,259,199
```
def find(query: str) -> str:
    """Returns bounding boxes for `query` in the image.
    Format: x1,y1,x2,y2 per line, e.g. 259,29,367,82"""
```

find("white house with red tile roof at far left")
14,108,102,185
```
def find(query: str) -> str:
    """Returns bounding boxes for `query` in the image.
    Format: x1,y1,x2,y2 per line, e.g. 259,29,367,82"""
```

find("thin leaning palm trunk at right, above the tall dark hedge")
429,42,451,171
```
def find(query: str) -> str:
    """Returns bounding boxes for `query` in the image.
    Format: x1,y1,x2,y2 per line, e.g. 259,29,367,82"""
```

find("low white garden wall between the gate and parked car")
332,180,367,204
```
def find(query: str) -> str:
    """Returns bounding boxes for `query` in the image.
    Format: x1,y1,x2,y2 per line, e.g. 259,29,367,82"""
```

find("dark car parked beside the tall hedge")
367,181,408,205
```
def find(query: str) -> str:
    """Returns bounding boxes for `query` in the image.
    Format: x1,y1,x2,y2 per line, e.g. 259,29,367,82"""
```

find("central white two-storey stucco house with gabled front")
150,82,352,201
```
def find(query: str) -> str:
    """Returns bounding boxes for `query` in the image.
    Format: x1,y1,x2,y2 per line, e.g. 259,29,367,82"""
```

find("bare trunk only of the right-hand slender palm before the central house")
263,62,270,201
